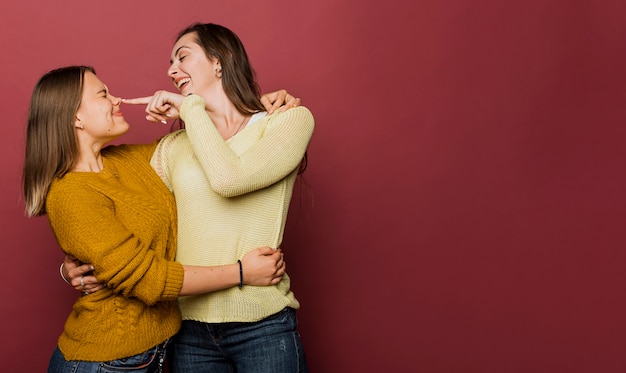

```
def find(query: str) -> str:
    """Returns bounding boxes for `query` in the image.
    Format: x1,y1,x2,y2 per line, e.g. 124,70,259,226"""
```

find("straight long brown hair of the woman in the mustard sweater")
22,66,95,216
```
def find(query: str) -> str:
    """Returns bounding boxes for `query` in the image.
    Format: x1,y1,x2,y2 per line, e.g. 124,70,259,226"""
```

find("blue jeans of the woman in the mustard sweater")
48,341,167,373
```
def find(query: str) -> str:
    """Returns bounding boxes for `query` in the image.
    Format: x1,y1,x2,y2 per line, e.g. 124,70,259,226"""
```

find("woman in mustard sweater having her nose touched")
23,66,284,372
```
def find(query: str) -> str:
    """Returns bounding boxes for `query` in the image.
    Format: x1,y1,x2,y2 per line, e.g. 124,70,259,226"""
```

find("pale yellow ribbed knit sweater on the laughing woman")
151,95,314,323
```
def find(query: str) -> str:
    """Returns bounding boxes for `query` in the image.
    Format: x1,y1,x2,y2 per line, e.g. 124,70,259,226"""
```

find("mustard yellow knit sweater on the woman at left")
46,144,184,361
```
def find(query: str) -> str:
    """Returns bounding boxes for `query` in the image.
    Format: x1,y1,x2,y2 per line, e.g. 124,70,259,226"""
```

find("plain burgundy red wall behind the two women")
0,0,626,372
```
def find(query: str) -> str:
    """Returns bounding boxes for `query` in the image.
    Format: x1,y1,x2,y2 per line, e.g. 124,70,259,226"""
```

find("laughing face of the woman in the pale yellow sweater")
167,33,221,96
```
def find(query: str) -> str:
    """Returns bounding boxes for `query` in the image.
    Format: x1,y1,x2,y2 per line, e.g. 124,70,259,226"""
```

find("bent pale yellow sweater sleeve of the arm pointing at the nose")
180,95,314,197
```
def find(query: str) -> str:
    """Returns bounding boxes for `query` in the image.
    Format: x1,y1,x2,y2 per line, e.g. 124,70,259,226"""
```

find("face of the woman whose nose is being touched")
76,72,129,142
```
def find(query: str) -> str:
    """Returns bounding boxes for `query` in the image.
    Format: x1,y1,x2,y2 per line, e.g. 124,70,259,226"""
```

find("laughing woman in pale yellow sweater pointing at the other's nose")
125,24,314,373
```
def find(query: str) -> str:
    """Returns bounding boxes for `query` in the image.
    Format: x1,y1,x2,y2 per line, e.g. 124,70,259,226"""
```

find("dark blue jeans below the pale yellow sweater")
169,308,309,373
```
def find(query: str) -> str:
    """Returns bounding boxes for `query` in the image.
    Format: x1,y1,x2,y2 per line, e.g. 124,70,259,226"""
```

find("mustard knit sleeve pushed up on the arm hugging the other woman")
47,181,184,305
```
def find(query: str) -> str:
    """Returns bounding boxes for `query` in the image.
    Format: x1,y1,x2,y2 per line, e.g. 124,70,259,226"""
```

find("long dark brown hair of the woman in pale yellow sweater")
176,23,308,173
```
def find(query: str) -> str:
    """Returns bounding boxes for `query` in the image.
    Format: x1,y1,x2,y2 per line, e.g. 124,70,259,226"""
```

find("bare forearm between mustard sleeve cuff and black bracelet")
180,263,239,296
